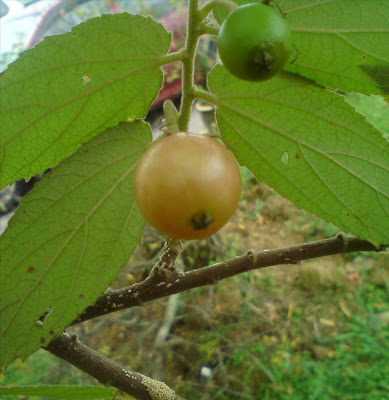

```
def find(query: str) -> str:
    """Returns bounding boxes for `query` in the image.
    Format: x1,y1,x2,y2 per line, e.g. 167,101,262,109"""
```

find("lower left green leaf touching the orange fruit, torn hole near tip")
0,121,151,365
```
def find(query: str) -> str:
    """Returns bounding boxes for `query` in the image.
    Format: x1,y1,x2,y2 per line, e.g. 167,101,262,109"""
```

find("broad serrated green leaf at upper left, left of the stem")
0,14,171,187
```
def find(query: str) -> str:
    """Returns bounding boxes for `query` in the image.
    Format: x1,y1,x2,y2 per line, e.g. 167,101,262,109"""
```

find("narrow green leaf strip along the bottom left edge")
0,385,115,400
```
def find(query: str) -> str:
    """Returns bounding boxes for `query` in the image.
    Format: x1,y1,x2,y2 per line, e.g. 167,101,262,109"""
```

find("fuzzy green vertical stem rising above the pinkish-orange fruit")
178,0,201,132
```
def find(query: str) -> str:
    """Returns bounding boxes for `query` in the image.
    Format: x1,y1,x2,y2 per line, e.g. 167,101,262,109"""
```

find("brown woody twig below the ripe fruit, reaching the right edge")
72,234,386,325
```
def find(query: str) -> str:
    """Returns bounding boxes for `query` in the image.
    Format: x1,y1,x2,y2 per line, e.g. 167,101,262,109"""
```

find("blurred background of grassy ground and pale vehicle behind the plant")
0,0,389,400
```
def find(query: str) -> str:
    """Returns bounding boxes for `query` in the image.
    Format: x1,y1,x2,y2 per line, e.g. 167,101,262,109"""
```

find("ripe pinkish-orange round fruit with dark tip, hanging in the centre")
135,133,242,240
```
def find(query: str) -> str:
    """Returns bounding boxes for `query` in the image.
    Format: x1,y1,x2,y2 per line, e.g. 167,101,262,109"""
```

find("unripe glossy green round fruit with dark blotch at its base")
217,4,292,81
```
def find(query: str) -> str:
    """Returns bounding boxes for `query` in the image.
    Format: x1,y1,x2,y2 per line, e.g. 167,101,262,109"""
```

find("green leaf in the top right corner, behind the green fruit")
214,0,389,97
